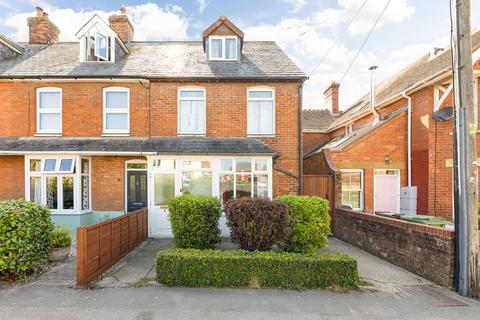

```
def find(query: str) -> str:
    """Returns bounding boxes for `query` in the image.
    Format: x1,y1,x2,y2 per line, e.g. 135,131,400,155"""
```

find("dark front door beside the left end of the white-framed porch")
127,170,148,212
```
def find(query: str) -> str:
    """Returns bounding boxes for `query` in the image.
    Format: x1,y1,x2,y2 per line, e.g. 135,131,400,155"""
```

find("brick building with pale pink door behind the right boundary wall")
303,31,480,220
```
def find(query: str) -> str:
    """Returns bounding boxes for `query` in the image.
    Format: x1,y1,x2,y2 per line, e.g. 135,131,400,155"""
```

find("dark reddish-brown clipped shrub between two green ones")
225,198,288,251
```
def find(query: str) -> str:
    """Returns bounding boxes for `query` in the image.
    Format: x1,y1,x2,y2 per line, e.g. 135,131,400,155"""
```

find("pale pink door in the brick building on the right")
374,169,400,213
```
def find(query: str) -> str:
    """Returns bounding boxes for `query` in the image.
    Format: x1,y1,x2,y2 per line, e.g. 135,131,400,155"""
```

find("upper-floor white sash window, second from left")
103,87,130,134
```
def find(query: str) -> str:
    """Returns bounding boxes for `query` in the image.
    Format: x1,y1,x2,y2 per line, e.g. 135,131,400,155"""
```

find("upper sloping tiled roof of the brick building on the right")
330,30,480,130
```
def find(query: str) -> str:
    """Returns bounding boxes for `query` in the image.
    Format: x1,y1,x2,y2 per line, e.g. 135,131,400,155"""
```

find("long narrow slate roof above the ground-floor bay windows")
0,137,276,155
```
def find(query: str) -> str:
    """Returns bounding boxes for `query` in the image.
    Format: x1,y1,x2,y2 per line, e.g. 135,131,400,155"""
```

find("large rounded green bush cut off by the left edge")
0,200,53,281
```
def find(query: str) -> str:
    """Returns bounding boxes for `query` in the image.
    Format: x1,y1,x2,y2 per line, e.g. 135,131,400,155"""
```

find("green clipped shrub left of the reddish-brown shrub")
168,194,221,249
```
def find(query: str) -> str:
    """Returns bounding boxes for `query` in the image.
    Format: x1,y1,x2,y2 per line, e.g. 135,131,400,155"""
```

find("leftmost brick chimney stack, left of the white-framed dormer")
27,7,60,44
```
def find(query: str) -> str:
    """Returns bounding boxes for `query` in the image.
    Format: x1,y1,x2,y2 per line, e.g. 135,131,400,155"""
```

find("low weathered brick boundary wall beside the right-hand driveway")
334,208,455,287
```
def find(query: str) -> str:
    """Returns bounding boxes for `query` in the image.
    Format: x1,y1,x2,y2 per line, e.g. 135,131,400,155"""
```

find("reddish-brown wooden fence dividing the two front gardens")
77,208,148,287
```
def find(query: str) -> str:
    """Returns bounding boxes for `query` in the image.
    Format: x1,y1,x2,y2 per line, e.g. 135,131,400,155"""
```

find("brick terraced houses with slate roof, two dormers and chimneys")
0,7,307,237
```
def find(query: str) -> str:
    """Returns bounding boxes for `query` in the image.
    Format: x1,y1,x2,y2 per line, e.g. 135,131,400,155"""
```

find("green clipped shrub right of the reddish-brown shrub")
277,196,330,253
